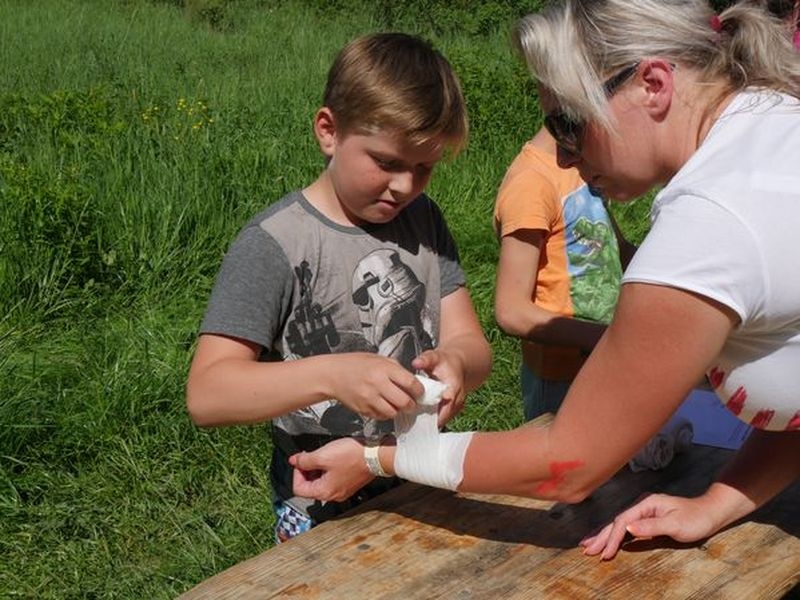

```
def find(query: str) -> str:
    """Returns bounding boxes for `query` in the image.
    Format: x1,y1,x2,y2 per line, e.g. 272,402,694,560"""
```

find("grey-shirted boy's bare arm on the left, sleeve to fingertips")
186,334,424,426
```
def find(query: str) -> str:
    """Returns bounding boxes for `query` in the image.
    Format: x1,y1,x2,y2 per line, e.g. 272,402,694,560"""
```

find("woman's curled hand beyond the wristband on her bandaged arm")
289,438,373,502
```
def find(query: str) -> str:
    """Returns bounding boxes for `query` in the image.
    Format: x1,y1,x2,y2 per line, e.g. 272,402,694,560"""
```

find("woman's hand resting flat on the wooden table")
581,494,719,560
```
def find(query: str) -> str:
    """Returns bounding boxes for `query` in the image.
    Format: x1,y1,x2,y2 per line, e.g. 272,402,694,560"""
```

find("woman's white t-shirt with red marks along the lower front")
623,90,800,430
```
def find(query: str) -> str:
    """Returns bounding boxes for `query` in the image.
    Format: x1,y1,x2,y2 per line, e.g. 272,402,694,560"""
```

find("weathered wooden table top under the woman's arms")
180,418,800,600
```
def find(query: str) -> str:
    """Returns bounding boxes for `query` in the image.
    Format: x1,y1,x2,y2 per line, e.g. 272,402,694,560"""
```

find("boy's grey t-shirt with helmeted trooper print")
201,192,465,510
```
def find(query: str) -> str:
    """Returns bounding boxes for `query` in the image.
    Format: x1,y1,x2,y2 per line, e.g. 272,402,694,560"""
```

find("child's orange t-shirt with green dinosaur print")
494,142,622,381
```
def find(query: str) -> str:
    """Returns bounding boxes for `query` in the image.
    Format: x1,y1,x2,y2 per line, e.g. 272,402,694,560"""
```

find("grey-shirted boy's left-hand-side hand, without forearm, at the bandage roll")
330,352,425,420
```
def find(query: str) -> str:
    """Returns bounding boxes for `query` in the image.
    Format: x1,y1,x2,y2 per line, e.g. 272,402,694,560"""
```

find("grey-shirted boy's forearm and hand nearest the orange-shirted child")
412,287,492,425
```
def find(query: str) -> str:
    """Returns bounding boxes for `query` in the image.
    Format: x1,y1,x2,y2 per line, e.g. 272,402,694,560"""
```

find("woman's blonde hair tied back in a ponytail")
514,0,800,128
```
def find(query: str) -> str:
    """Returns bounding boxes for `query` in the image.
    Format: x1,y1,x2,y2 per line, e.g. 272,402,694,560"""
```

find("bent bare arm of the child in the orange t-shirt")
494,229,606,352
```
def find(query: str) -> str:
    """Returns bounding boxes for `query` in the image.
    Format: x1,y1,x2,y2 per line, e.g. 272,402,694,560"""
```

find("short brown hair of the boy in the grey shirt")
323,33,469,155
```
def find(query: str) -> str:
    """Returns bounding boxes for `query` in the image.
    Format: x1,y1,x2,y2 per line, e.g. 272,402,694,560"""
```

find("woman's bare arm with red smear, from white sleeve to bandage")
385,284,740,502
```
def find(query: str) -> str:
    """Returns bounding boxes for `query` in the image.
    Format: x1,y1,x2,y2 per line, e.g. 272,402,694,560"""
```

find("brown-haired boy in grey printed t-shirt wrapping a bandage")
187,33,491,541
